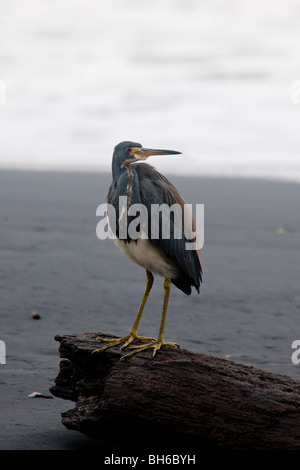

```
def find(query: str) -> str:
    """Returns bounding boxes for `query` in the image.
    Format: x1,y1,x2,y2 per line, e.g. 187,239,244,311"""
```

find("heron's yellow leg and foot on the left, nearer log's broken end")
93,271,156,352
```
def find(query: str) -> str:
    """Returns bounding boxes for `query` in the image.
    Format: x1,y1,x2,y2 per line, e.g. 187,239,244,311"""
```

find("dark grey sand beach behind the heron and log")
0,171,300,451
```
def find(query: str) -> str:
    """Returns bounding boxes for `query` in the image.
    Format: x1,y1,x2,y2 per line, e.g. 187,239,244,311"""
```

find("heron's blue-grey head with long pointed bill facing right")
113,142,181,168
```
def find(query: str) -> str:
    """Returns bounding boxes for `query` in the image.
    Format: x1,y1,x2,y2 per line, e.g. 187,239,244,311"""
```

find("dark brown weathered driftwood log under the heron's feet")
50,333,300,453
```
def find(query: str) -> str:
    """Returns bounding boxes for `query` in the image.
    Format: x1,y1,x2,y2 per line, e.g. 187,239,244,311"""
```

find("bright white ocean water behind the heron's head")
0,0,300,181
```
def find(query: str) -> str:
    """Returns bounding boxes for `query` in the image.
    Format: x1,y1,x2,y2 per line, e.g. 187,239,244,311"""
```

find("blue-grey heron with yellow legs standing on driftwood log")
94,141,203,359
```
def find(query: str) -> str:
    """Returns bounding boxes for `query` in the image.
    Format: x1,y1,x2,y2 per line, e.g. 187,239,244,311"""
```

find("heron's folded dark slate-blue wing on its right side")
136,164,202,294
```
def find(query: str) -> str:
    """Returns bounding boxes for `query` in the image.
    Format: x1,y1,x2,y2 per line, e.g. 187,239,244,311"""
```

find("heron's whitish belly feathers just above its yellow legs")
115,238,179,279
